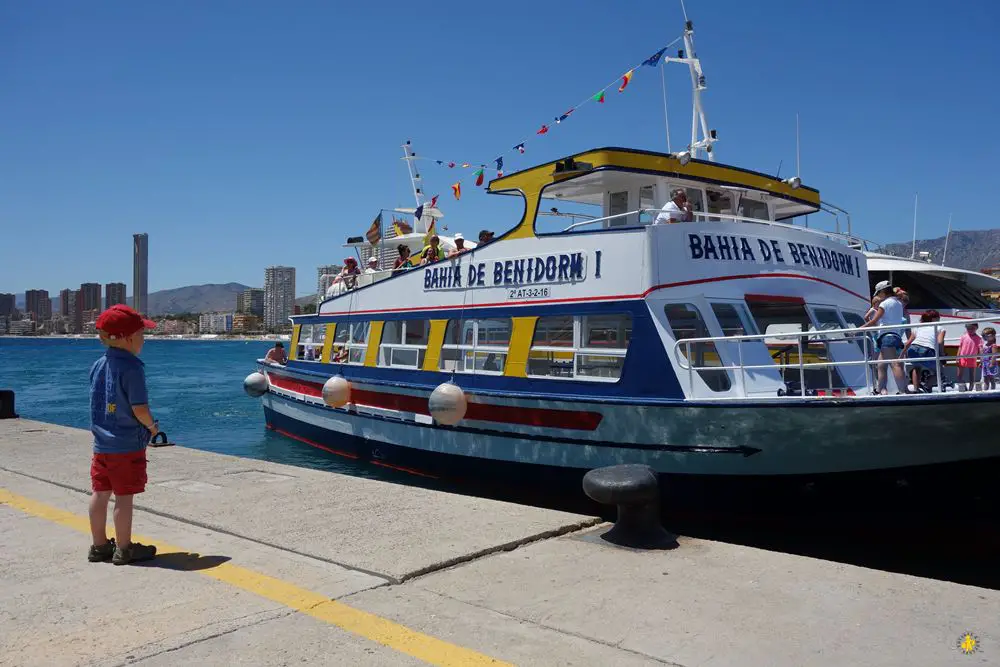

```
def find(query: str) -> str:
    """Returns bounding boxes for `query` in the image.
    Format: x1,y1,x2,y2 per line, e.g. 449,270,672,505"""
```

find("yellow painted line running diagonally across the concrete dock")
0,488,511,667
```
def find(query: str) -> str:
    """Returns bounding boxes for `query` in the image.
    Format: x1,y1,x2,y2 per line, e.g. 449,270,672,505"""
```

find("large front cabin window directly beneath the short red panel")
746,294,844,391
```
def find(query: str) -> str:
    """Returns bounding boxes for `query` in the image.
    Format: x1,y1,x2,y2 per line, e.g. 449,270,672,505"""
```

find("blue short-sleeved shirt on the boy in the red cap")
90,347,152,454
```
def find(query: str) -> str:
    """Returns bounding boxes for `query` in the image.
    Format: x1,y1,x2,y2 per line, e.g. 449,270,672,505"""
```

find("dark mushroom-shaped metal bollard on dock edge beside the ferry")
583,464,677,549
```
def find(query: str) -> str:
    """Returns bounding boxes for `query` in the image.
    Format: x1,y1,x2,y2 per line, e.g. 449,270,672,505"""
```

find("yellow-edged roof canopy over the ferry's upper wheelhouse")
489,148,820,220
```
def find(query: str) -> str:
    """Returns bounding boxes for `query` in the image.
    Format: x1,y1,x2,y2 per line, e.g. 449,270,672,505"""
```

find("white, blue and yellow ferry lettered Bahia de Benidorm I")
247,22,1000,483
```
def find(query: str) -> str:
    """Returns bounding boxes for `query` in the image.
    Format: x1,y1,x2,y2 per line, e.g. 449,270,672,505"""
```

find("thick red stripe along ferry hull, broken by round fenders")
268,373,603,431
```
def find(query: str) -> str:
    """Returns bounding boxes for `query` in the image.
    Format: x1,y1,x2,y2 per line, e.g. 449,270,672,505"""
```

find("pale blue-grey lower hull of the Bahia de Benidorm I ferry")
262,389,1000,477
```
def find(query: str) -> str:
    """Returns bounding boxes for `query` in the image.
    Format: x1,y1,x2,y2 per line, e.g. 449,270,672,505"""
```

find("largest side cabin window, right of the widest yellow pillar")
528,313,632,382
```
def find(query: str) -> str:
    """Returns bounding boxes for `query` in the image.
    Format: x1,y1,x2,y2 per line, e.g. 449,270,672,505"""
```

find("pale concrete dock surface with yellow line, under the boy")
0,419,1000,667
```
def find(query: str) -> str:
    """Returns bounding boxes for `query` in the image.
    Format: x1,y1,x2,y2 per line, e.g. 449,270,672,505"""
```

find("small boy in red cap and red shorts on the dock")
87,305,157,565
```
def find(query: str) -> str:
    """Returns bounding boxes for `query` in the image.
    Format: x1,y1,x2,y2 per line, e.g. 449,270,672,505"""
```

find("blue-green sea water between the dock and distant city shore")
0,338,399,479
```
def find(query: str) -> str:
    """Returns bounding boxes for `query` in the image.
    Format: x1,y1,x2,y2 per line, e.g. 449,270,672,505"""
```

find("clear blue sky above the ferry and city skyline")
0,0,1000,294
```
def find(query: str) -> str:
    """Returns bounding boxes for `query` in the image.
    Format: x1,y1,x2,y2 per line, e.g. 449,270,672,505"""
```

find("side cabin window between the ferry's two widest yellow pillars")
441,317,512,375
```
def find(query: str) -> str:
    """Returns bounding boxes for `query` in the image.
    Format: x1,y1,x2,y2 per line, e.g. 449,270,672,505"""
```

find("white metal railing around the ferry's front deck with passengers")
673,317,994,401
